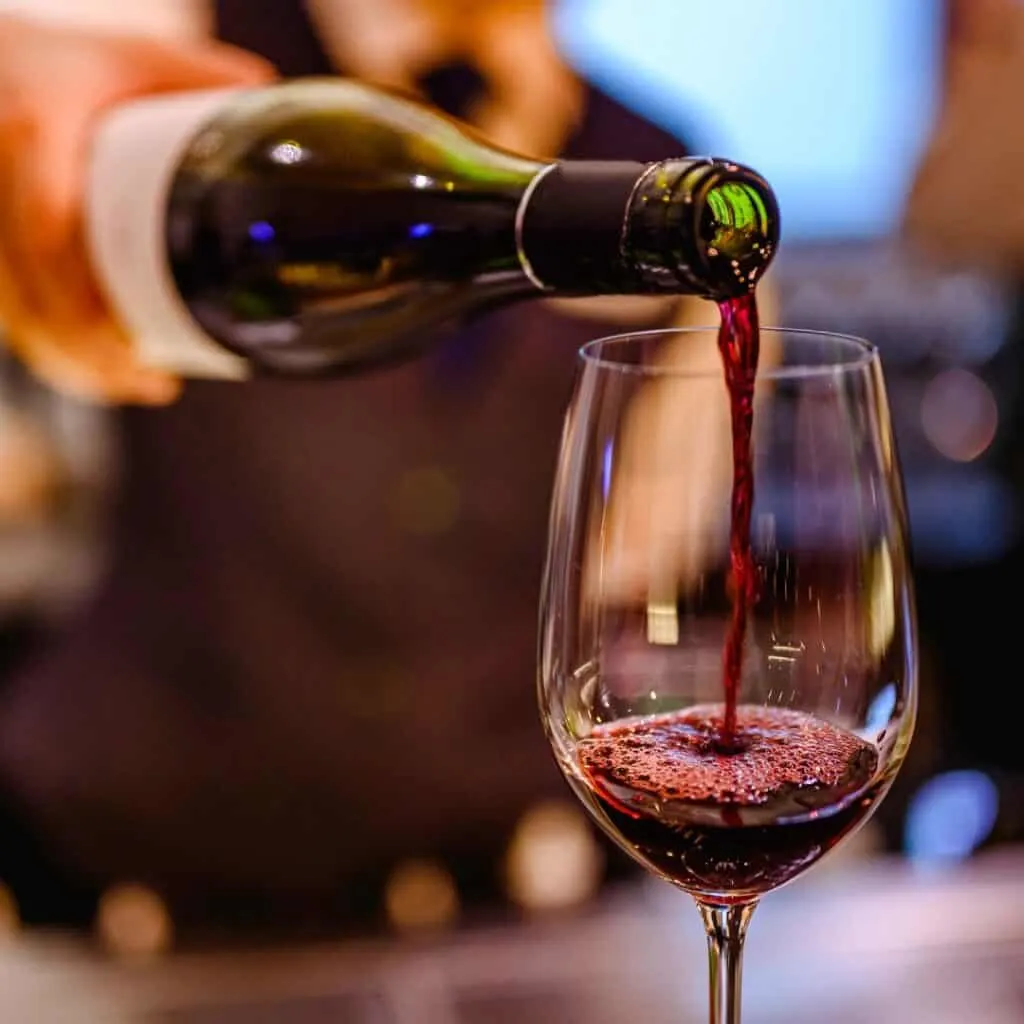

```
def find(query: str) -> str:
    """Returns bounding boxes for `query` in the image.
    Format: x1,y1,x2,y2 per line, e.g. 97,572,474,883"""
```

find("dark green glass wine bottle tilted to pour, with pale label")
86,79,778,378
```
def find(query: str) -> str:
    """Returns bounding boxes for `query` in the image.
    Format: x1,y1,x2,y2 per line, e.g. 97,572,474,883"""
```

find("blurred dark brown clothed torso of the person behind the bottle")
0,0,692,929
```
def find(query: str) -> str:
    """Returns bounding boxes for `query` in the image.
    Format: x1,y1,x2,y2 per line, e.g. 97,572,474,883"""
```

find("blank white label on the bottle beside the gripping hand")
85,89,256,380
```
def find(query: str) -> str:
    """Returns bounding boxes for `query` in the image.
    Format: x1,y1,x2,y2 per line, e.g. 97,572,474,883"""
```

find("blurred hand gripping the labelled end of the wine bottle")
0,16,273,404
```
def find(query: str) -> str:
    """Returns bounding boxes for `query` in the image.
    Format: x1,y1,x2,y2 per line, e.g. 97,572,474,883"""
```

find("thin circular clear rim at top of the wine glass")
577,325,879,381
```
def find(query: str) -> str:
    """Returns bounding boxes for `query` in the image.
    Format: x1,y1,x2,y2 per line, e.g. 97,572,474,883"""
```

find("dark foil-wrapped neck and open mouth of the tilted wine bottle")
516,158,778,300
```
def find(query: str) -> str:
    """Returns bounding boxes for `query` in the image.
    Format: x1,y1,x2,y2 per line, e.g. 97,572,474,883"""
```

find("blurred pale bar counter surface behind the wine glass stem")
0,848,1024,1024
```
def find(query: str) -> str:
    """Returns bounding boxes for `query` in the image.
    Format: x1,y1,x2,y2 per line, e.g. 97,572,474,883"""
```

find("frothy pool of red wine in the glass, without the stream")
577,705,884,903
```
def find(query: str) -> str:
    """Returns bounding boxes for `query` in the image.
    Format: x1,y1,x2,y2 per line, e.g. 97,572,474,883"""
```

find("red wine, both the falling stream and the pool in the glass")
577,290,885,904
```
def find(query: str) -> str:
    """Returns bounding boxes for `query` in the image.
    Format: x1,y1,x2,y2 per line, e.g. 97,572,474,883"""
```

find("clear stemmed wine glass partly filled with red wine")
539,329,916,1024
